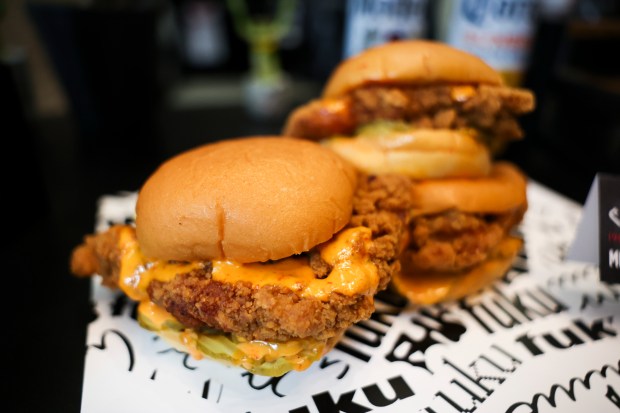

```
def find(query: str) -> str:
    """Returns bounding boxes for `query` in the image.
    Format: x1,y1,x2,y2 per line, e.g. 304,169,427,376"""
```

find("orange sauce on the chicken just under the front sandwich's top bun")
119,227,379,301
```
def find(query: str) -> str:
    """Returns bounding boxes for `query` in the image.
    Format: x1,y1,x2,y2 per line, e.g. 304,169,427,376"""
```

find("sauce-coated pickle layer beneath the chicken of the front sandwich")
138,302,344,377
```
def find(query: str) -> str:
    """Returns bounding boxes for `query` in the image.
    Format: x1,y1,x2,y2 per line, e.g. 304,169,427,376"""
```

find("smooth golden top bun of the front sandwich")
136,136,356,263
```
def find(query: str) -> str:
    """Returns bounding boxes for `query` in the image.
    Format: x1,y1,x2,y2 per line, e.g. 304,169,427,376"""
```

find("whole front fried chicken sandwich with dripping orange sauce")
71,136,400,376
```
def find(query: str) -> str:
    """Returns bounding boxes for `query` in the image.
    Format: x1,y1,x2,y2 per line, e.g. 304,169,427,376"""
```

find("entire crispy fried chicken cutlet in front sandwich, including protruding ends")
71,176,410,341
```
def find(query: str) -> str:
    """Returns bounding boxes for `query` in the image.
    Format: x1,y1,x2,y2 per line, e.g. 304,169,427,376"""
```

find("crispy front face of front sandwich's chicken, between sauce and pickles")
148,272,374,341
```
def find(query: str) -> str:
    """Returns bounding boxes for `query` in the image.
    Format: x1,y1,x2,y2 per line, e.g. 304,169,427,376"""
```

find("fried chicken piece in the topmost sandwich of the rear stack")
283,85,534,144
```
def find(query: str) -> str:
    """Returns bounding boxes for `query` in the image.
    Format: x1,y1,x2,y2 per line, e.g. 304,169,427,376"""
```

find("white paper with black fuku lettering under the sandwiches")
82,182,620,413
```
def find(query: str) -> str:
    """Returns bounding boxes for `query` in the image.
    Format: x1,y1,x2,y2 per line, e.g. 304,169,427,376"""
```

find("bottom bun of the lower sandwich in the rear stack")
392,233,523,305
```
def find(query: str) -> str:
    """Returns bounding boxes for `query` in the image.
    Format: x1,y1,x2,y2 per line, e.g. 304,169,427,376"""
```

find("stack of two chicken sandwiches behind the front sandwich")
283,40,534,304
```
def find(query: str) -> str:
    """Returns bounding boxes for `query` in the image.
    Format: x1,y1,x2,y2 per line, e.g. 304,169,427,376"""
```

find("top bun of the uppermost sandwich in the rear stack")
323,40,503,98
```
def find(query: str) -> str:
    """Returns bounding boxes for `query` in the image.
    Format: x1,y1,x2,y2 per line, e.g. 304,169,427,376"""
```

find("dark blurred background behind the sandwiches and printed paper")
0,0,620,411
